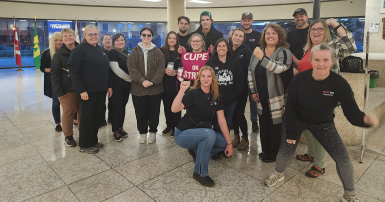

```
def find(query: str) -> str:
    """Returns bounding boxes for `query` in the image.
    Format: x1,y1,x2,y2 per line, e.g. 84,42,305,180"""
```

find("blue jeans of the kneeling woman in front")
174,128,227,177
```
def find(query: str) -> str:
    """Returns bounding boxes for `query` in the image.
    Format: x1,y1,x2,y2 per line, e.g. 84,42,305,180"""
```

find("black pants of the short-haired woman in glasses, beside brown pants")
77,91,106,148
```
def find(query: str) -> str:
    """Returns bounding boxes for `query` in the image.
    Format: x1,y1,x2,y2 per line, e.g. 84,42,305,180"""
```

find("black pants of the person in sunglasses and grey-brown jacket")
132,94,161,134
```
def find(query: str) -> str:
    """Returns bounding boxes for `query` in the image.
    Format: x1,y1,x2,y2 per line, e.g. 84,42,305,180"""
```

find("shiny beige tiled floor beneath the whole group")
0,69,385,202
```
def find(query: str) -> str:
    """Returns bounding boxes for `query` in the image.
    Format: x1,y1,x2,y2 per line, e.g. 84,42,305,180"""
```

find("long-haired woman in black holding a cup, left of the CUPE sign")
160,31,181,136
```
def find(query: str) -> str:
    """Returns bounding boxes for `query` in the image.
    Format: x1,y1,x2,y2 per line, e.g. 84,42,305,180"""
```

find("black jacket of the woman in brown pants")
51,42,79,97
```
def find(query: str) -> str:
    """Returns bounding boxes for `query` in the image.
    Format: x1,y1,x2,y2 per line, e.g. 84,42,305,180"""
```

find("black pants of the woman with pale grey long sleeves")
108,84,131,132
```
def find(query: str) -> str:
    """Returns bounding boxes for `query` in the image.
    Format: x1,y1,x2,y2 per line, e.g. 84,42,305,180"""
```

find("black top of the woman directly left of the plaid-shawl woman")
231,44,253,91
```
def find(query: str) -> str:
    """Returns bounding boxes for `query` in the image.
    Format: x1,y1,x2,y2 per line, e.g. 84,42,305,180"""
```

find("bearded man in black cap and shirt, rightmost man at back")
287,8,309,73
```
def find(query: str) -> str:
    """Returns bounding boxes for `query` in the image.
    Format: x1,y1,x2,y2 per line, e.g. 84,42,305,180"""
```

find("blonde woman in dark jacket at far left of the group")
40,32,63,132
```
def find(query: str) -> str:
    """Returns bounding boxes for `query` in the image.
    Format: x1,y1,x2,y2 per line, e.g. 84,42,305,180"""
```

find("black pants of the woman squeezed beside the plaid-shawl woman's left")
233,89,249,138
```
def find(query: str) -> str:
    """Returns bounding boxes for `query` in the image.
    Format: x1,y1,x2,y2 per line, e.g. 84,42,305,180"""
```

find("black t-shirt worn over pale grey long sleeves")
107,49,131,88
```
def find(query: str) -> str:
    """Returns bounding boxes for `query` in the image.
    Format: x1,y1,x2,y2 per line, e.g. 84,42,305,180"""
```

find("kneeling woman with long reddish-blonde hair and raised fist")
171,66,233,187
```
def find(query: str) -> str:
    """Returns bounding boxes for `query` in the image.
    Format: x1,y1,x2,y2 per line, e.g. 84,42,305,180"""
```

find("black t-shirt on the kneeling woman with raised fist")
177,88,224,131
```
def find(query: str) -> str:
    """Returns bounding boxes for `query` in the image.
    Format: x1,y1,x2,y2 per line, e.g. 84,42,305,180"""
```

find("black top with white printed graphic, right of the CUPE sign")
206,51,246,104
